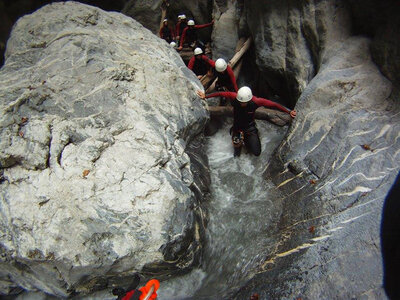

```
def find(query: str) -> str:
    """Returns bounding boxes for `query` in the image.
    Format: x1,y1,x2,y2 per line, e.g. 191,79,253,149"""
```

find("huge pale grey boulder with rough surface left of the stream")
0,1,208,297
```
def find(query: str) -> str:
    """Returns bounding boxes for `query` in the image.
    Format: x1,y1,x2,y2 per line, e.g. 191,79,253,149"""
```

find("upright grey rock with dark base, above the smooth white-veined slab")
245,0,350,107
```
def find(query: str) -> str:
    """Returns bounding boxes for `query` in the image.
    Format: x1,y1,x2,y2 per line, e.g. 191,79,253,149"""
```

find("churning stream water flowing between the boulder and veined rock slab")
158,121,287,300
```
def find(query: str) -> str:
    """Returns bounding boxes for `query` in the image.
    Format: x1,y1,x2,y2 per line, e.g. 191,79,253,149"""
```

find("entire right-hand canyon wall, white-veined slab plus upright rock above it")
234,1,400,299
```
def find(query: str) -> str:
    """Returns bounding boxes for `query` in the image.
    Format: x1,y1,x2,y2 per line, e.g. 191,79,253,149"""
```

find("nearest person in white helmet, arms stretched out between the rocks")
197,86,296,156
